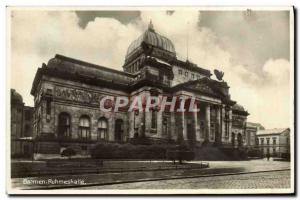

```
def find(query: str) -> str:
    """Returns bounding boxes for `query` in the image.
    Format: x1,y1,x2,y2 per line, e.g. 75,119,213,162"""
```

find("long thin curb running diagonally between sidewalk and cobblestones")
28,169,291,190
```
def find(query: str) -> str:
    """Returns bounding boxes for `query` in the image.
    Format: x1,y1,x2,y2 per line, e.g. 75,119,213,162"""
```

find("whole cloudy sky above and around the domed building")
10,10,293,128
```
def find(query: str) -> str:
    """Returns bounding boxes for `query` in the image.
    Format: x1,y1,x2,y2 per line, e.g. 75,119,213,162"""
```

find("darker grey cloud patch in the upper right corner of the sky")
200,10,290,74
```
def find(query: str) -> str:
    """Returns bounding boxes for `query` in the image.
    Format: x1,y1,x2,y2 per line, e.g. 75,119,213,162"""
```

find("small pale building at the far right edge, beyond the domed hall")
257,128,290,157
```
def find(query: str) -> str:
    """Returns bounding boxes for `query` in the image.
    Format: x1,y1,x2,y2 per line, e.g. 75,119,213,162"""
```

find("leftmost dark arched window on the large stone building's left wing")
58,113,71,138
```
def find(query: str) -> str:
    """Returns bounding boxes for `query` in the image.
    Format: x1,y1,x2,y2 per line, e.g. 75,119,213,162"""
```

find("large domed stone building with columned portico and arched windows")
31,23,248,153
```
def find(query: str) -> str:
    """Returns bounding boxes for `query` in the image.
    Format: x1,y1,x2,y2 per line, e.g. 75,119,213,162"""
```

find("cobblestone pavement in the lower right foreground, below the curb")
80,170,291,190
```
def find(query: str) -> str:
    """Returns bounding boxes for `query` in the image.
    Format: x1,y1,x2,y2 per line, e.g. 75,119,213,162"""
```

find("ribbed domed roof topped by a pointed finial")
126,21,176,59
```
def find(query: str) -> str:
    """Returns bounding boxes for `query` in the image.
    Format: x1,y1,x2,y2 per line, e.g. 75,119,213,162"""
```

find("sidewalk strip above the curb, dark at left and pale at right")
12,160,290,189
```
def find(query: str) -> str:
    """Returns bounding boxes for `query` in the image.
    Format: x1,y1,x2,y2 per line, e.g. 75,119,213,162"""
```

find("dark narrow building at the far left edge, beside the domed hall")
10,89,34,157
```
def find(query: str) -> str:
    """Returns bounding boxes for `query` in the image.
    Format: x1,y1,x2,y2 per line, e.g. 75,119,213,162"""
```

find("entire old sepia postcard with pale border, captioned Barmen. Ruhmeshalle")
6,7,295,195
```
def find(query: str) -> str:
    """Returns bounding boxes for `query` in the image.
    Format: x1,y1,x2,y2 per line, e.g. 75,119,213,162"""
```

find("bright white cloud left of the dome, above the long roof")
11,11,141,105
